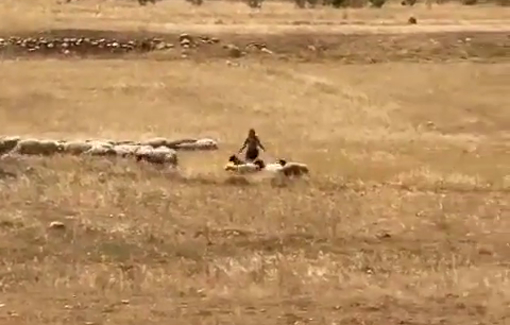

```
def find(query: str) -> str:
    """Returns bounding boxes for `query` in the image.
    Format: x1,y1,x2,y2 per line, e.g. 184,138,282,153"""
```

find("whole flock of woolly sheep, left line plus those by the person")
0,136,309,176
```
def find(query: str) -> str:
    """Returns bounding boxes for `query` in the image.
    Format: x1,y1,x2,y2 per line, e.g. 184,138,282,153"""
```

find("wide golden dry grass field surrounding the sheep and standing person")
0,60,510,324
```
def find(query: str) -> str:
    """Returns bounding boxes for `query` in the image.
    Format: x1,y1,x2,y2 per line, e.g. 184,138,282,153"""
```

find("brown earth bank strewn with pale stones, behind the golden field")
0,30,510,63
